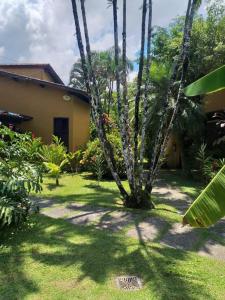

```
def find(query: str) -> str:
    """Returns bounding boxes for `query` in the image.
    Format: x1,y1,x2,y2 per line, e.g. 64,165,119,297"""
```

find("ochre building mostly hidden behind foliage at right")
166,90,225,168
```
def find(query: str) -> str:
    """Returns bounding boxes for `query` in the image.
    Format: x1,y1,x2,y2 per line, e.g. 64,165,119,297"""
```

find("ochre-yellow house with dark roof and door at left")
0,64,90,151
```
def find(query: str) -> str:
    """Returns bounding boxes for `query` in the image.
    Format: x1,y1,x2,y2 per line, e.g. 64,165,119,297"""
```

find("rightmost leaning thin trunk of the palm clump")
145,0,198,191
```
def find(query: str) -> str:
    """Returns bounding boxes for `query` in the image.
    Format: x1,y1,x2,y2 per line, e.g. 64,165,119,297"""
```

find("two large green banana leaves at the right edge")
183,65,225,227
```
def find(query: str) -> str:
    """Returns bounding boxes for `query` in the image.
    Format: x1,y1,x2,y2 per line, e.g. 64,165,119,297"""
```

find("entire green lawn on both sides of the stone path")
0,174,225,300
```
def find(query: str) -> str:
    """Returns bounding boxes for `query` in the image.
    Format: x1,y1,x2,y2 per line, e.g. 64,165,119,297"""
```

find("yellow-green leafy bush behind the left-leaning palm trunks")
81,130,126,178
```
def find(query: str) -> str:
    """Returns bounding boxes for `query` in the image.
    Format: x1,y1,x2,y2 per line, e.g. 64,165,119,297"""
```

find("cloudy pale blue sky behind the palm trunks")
0,0,205,84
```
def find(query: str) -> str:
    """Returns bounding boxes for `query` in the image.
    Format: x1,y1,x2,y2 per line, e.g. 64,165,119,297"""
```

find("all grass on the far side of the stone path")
33,171,201,222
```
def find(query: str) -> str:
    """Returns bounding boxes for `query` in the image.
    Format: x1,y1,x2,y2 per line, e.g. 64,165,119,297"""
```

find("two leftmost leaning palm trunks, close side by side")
71,0,128,199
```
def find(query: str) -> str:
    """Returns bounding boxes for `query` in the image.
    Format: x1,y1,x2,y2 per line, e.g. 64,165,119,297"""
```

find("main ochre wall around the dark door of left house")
0,78,90,151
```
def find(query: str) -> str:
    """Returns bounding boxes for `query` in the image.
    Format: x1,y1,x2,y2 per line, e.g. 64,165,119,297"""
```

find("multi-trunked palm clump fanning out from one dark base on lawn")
71,0,199,208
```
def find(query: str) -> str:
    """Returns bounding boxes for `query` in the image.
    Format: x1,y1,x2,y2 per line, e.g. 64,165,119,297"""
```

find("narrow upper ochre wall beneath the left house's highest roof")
0,66,54,82
